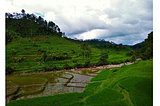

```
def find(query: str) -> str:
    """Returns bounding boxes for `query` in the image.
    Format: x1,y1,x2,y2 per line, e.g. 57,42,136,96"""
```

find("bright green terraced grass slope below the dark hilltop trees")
6,36,131,72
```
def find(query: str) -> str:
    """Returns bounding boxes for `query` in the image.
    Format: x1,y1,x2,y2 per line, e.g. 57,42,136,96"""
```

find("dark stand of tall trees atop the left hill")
5,9,62,37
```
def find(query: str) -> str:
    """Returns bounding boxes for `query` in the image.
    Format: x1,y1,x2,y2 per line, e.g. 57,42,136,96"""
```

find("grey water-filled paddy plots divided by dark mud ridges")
6,72,95,102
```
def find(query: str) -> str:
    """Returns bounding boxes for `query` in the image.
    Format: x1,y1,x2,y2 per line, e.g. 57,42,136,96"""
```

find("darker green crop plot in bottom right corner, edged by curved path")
119,77,153,106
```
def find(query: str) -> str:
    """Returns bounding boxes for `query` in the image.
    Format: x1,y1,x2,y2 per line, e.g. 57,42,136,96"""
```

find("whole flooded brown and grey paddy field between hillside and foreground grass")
6,64,132,102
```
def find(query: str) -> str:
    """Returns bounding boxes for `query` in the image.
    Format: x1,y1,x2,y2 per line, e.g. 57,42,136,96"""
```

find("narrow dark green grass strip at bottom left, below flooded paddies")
7,93,82,106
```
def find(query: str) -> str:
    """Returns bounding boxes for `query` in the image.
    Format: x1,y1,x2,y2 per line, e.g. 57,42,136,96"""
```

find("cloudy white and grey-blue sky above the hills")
5,0,153,45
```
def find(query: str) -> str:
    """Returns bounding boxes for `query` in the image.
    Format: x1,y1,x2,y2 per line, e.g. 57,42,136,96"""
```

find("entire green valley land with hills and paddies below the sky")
5,6,153,106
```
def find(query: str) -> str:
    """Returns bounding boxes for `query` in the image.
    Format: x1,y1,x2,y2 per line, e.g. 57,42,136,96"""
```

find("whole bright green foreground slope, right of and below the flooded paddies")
6,60,153,106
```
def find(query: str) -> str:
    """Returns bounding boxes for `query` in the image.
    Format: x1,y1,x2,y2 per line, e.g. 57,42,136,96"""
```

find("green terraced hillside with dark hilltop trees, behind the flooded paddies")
6,10,131,74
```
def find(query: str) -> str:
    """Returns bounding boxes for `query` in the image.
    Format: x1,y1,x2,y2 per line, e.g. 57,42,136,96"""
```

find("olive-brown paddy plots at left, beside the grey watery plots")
6,72,63,99
